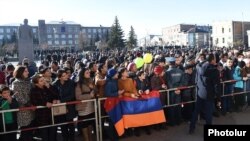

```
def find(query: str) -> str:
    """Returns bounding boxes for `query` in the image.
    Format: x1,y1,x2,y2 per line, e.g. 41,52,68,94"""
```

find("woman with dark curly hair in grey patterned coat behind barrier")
12,66,34,141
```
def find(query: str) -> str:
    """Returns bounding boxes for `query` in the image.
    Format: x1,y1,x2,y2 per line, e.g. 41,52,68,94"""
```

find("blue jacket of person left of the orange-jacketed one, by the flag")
104,78,118,97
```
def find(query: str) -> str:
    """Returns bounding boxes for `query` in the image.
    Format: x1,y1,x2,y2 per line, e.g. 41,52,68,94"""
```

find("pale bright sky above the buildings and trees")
0,0,250,38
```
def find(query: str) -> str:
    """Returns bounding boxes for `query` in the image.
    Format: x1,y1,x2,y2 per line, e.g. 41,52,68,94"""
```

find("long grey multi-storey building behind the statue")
0,20,110,50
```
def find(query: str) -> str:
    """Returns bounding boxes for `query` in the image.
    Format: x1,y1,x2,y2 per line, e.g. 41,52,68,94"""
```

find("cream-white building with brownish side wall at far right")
212,21,250,47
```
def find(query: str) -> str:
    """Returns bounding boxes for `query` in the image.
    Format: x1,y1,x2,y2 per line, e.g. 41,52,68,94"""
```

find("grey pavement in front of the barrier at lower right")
110,107,250,141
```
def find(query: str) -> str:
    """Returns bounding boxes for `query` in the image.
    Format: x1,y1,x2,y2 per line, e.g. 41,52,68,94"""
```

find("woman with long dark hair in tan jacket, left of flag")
75,68,95,141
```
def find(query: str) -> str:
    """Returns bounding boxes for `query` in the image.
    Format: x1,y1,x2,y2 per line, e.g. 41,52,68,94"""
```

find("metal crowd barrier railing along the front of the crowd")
0,79,250,141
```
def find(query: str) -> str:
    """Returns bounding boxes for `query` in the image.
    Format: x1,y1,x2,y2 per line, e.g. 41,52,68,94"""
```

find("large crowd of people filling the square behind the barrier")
0,48,250,141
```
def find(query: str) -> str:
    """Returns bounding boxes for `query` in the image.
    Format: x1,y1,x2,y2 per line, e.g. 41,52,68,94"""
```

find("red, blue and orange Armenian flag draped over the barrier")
104,91,166,136
